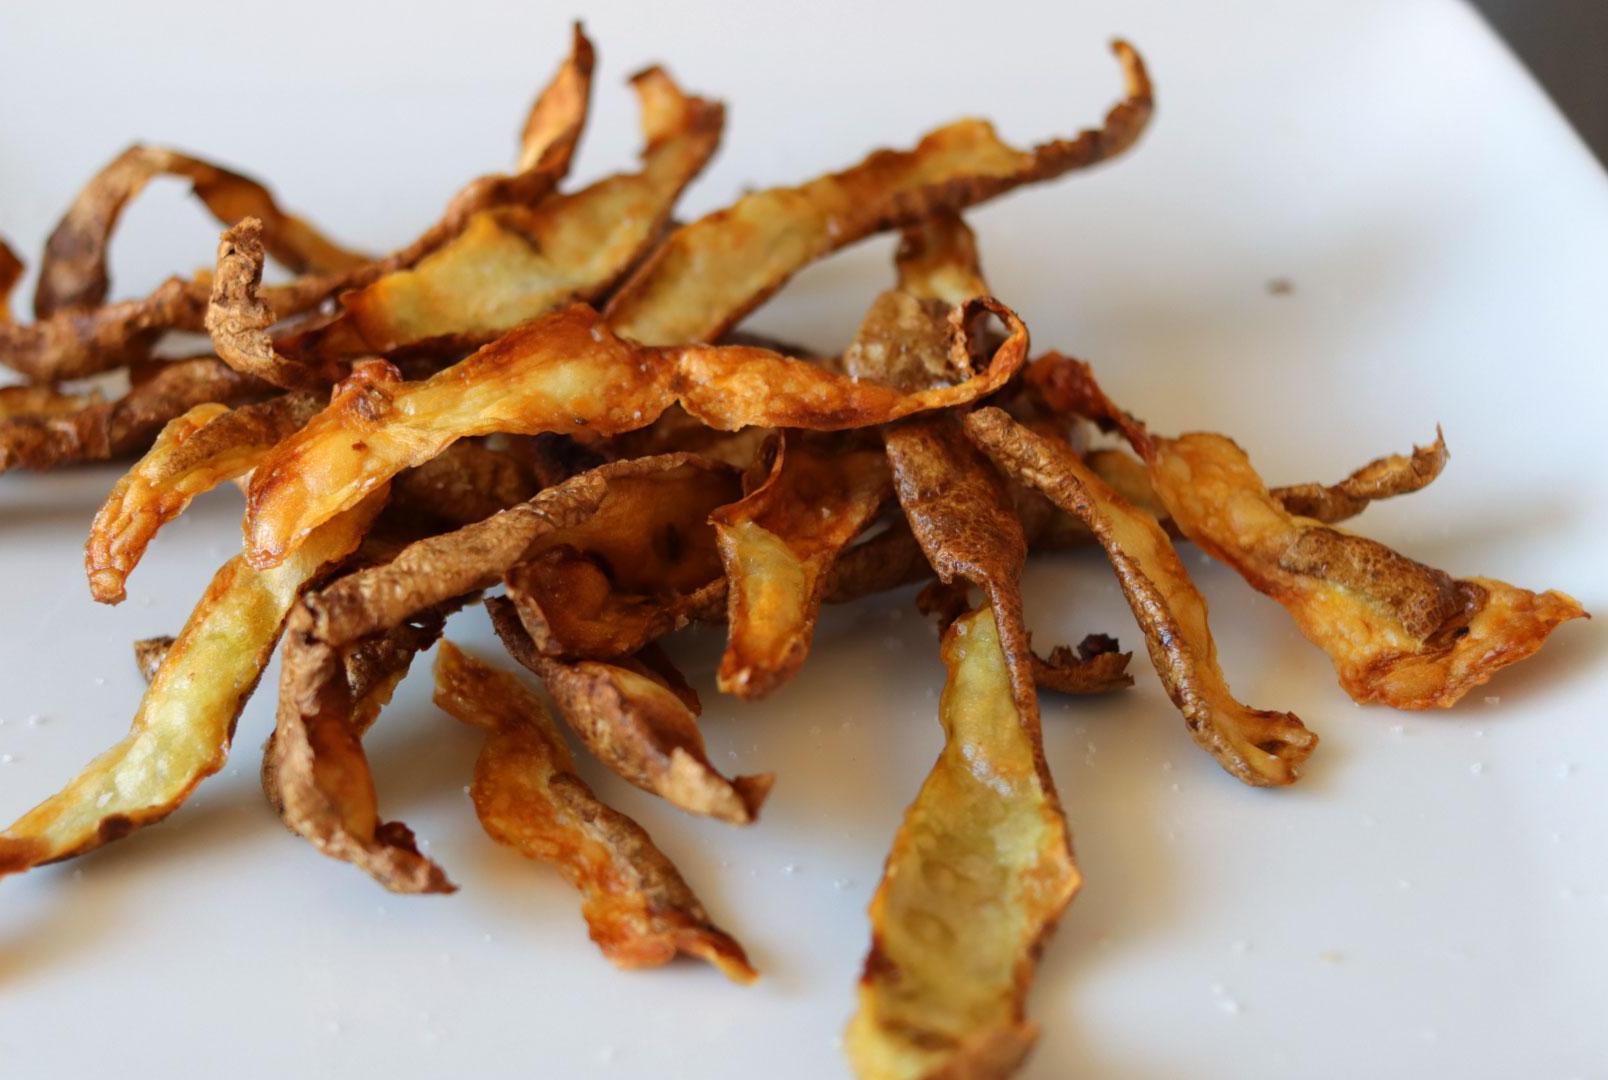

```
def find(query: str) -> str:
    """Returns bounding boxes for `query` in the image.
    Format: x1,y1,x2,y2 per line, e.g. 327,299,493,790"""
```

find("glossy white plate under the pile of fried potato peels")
0,0,1608,1080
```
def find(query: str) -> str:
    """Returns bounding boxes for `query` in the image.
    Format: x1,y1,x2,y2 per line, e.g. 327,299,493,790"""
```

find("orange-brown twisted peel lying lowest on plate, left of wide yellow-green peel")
436,641,757,984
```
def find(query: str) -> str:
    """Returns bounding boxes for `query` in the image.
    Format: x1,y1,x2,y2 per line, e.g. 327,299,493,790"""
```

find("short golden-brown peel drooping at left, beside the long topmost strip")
84,394,322,604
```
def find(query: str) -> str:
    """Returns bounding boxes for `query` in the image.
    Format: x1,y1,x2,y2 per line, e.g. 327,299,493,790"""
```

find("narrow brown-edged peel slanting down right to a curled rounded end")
965,408,1317,788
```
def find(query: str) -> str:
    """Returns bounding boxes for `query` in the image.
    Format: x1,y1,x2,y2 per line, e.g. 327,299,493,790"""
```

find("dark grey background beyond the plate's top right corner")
1475,0,1608,164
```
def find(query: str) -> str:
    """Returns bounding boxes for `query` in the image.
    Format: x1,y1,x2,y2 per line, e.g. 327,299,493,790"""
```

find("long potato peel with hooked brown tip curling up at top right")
608,42,1153,346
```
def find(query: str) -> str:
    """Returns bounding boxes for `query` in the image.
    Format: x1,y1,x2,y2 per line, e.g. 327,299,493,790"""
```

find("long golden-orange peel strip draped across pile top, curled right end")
244,299,1028,566
